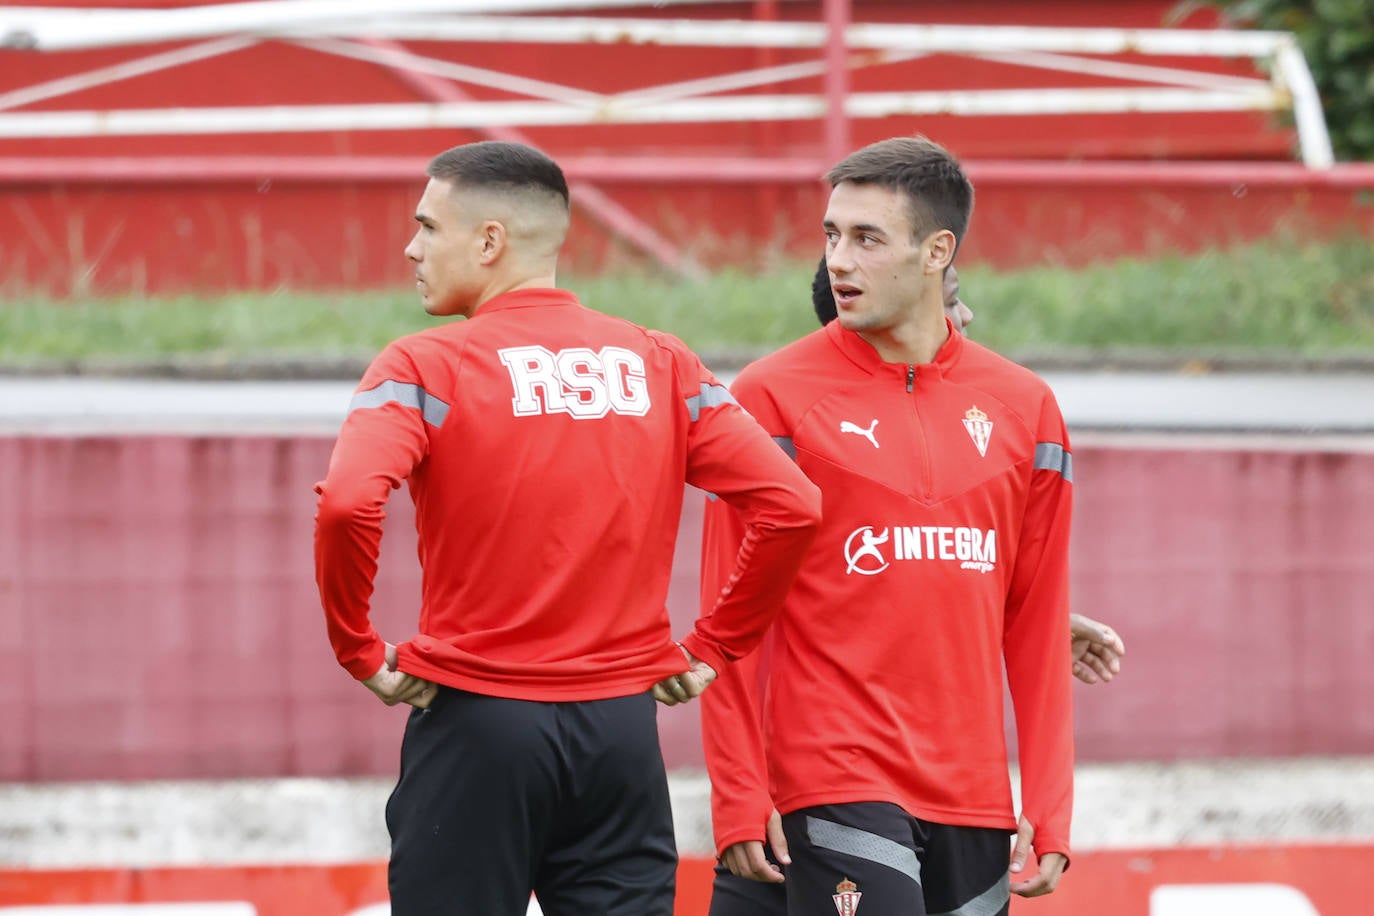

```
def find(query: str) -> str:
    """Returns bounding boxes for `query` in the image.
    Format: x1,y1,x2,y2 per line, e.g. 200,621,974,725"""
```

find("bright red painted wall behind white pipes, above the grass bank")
0,0,1374,297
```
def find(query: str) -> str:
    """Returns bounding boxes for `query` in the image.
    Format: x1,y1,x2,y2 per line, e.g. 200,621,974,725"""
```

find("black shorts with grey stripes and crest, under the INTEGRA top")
710,802,1011,916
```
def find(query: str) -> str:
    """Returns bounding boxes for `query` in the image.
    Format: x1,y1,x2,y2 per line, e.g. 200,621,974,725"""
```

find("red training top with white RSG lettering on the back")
315,288,820,700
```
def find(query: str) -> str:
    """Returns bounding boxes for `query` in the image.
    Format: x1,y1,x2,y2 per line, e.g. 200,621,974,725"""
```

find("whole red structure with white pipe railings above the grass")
0,0,1374,295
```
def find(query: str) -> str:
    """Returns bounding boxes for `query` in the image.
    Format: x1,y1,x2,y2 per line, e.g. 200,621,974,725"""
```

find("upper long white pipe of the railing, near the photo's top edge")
8,10,1285,58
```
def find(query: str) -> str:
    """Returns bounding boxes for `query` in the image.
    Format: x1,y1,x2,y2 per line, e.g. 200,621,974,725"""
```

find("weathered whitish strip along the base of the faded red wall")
0,757,1374,868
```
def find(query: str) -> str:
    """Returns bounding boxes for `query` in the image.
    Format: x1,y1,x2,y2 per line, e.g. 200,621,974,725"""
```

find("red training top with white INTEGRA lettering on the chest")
702,321,1073,854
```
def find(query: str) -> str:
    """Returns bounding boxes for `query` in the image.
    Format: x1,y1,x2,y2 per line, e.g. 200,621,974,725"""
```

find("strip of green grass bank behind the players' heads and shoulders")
0,238,1374,367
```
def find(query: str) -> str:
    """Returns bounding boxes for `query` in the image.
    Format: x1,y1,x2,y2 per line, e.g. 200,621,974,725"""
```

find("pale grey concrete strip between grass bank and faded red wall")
0,372,1374,435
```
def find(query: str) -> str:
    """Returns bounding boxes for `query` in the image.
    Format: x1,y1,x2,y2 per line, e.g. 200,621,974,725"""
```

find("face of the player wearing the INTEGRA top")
824,181,925,332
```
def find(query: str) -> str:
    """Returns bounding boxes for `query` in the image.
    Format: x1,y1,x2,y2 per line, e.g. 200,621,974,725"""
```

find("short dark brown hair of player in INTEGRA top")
826,137,973,246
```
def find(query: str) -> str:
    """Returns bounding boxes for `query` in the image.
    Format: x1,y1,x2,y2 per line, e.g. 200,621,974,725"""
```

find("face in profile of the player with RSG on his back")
405,179,482,316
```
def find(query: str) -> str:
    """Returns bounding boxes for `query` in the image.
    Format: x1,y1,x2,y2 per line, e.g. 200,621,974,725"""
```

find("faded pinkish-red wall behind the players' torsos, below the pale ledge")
0,437,1374,780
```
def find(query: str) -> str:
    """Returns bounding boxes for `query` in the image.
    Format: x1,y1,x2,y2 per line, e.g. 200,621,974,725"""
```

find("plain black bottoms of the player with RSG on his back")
386,688,677,916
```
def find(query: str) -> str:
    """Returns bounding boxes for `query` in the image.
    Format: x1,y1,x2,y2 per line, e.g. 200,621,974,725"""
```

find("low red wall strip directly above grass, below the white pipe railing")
0,158,1374,297
